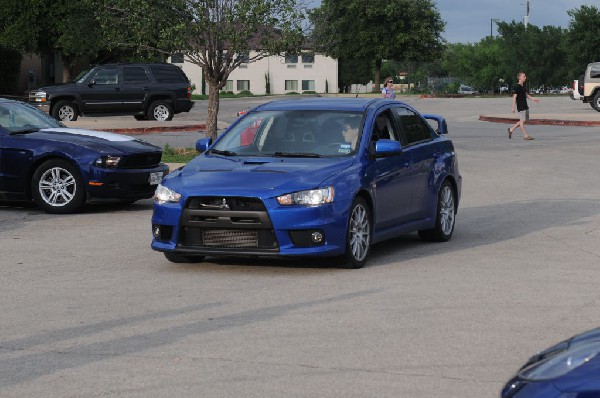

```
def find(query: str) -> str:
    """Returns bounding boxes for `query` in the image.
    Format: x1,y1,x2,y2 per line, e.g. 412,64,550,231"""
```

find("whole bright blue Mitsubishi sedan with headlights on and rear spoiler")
152,98,461,268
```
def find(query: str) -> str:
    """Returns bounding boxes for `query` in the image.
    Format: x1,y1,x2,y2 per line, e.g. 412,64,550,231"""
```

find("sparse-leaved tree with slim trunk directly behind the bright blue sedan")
99,0,304,138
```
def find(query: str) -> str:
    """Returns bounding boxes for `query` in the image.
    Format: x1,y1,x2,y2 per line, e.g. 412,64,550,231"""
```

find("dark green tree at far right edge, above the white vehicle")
565,6,600,76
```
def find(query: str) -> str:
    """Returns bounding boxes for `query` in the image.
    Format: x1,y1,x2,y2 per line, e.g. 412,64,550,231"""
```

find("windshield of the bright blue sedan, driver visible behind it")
211,110,364,157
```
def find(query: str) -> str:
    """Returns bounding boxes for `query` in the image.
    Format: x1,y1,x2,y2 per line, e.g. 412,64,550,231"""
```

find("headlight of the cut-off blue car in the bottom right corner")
519,341,600,381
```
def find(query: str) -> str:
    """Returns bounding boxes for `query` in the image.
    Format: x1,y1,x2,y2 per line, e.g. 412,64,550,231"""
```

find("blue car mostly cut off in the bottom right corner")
501,328,600,398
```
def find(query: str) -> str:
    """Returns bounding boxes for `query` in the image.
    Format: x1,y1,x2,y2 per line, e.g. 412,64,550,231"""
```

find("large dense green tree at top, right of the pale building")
310,0,444,89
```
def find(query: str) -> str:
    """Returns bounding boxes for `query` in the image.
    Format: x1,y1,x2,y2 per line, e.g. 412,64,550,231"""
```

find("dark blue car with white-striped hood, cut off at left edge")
0,99,169,213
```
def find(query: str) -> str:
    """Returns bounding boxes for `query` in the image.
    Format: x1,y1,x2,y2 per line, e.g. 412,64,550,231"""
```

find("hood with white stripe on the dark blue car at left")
27,127,161,152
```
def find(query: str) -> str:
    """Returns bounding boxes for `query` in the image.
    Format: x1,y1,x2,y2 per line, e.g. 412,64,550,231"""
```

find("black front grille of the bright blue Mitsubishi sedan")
179,196,278,252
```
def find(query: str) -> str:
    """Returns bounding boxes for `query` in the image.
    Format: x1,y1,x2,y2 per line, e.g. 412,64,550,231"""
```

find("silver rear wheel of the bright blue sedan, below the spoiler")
419,180,456,242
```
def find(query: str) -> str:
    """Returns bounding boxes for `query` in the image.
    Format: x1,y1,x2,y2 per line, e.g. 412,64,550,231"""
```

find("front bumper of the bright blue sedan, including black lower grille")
152,200,349,257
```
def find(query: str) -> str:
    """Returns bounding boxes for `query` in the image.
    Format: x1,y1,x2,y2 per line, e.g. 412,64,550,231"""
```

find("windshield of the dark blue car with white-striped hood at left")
0,102,64,133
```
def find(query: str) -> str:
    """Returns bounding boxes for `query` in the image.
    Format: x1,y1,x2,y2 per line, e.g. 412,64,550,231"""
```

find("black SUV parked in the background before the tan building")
29,64,194,121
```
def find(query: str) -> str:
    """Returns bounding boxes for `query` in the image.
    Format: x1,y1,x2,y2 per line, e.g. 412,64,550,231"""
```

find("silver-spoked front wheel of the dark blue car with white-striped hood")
31,159,85,214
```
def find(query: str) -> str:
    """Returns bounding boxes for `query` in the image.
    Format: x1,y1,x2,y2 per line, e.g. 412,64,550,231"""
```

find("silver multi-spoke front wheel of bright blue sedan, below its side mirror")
340,198,371,268
